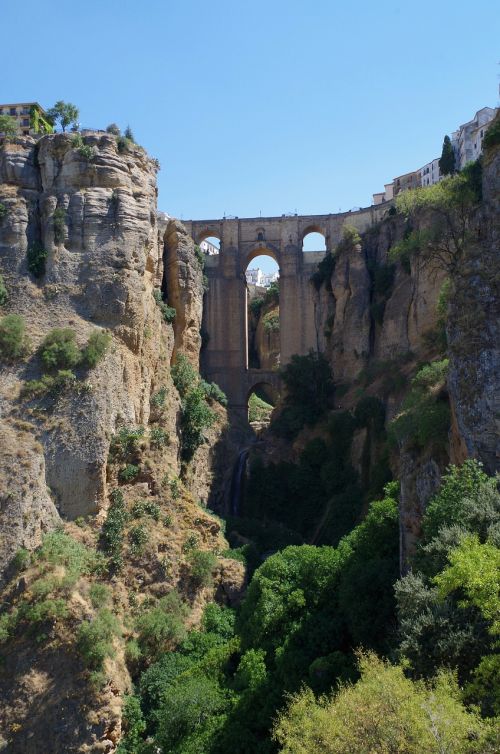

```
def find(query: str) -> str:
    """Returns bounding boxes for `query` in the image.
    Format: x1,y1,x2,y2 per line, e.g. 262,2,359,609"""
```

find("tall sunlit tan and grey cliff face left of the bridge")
0,133,211,570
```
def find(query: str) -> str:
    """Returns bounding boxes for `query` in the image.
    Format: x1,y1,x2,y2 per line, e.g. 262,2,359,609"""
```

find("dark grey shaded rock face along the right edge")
448,147,500,474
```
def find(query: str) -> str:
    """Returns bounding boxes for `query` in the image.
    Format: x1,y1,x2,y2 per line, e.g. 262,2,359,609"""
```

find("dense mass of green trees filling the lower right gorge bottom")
115,461,500,754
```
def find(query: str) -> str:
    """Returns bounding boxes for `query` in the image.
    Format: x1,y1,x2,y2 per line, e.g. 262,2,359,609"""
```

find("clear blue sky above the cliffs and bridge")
0,0,500,219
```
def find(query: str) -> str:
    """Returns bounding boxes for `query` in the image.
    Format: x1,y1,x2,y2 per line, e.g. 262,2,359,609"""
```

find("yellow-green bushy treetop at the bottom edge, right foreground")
274,654,493,754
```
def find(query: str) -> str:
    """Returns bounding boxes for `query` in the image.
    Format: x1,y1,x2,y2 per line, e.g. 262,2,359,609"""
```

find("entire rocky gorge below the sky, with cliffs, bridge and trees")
0,116,500,754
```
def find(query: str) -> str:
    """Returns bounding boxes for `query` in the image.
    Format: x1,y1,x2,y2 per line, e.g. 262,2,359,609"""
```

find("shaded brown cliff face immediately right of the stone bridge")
324,218,444,383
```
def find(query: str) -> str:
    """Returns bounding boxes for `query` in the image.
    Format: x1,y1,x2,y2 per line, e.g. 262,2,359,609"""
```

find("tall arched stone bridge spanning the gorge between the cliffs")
184,205,387,413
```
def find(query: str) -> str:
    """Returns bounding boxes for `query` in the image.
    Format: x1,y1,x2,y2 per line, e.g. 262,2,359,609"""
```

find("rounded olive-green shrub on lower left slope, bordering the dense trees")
136,590,189,659
